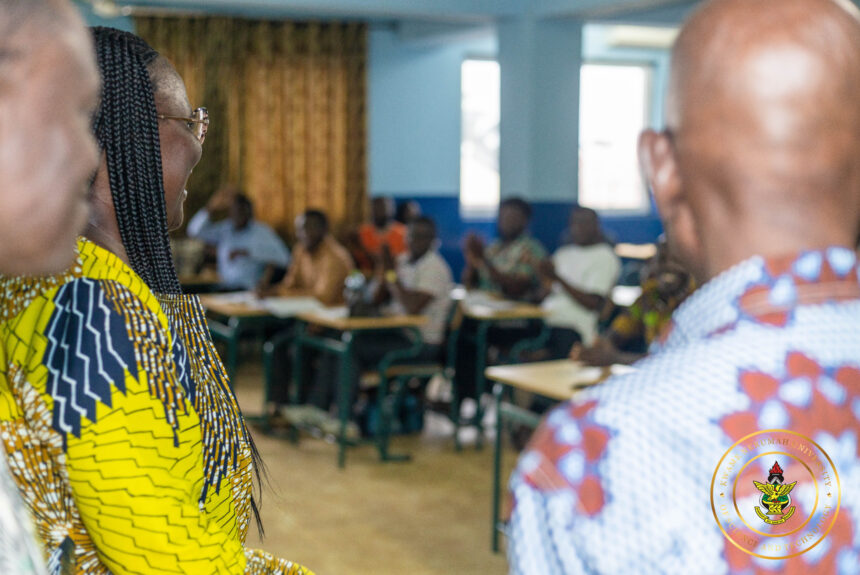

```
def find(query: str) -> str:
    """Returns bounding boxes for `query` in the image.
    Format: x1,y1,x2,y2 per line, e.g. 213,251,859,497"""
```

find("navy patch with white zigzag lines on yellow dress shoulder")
43,279,137,450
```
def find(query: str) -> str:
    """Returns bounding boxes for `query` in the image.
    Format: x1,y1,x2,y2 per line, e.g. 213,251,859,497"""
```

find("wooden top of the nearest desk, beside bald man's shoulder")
484,359,633,401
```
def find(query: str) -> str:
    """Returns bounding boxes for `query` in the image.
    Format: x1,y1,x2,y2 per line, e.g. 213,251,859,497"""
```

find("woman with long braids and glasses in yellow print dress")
0,28,310,575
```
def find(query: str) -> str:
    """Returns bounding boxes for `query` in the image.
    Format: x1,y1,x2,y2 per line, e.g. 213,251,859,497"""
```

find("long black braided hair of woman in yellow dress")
93,27,182,294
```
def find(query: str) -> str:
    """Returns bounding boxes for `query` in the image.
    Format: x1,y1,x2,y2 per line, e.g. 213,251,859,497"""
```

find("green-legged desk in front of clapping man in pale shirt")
291,308,427,467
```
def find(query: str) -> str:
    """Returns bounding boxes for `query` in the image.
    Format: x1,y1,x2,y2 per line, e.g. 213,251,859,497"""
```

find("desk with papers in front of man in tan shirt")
199,292,322,386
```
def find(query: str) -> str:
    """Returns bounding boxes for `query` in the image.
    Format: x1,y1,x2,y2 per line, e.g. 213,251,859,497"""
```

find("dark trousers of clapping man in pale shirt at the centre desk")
307,331,441,410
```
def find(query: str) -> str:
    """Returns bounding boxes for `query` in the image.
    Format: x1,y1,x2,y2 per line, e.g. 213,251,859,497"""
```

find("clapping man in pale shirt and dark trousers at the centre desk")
286,217,453,435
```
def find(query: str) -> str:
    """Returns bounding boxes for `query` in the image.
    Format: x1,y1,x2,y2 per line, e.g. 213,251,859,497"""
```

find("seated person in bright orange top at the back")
349,198,406,277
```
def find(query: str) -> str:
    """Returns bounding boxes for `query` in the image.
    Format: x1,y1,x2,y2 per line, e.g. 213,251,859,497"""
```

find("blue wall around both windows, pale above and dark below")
368,19,668,274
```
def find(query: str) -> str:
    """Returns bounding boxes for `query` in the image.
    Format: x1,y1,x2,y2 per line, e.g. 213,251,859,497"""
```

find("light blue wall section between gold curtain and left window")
368,26,496,197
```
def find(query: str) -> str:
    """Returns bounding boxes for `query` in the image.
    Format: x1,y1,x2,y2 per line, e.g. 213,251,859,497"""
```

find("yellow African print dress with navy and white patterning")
0,240,310,575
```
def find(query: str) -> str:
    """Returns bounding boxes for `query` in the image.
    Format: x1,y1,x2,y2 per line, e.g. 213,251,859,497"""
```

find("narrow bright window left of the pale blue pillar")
460,60,501,217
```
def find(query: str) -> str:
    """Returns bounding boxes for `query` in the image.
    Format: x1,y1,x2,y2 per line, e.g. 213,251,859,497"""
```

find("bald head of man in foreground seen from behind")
641,0,860,279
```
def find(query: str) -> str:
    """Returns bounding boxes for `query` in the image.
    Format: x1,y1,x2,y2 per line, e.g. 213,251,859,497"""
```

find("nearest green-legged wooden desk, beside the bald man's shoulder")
486,359,633,553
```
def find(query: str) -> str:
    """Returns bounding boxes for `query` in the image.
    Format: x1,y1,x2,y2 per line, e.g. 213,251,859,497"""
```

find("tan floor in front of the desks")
236,363,515,575
